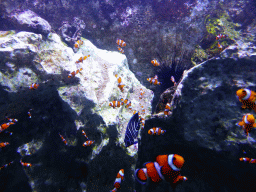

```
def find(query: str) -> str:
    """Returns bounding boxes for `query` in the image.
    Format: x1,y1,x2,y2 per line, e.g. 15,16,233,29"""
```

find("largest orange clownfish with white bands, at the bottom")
135,154,187,185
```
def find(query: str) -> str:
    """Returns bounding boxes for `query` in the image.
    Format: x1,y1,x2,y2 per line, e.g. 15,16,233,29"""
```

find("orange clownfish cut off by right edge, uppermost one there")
236,89,256,112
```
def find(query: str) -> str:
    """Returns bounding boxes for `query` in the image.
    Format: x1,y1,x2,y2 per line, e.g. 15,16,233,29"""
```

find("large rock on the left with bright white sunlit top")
0,31,153,191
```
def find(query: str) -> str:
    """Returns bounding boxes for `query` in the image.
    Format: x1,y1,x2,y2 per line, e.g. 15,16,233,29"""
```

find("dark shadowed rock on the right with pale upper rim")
137,44,256,191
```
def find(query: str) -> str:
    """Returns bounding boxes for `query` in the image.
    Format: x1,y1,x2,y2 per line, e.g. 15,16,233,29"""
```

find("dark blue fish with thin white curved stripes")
124,113,140,147
